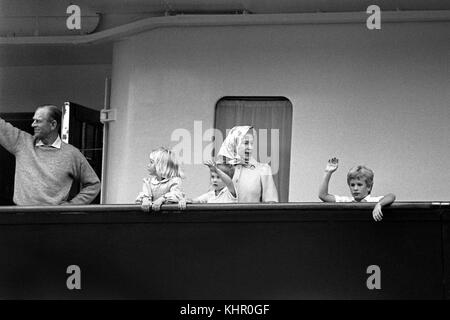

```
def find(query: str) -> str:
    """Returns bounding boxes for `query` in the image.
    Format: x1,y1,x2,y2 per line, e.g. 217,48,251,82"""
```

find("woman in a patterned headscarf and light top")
217,126,278,202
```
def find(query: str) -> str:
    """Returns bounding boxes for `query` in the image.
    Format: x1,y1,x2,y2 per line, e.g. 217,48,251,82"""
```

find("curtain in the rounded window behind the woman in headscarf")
215,98,292,202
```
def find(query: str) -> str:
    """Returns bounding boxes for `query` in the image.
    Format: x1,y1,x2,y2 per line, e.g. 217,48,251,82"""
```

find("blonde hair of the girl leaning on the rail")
150,147,184,179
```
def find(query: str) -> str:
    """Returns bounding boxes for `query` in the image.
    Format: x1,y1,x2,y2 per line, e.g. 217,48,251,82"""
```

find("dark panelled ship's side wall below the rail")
0,203,450,299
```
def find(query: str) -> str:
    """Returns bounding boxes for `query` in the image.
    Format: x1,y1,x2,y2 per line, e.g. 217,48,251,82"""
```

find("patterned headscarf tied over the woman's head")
218,126,254,166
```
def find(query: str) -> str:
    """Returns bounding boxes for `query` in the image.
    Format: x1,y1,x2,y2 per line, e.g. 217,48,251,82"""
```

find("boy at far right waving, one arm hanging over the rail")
319,158,395,221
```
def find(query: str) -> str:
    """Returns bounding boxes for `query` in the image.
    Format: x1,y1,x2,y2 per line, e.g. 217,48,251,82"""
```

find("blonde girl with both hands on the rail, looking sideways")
136,147,185,212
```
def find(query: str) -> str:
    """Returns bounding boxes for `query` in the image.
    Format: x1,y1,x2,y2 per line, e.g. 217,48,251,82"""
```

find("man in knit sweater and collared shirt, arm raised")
0,105,100,205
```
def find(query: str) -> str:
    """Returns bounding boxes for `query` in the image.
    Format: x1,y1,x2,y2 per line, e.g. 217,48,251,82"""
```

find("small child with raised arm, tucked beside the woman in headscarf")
192,161,237,203
